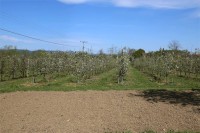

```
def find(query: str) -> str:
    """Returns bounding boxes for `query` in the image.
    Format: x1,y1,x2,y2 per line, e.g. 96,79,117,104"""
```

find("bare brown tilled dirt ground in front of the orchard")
0,91,200,133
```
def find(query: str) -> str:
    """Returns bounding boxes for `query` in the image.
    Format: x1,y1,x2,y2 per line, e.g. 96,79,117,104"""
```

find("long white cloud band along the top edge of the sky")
58,0,200,9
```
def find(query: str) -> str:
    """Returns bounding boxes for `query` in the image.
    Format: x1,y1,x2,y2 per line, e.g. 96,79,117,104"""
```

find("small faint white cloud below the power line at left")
0,35,33,43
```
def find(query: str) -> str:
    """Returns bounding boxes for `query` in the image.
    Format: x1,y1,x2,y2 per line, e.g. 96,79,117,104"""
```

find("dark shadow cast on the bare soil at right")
132,89,200,113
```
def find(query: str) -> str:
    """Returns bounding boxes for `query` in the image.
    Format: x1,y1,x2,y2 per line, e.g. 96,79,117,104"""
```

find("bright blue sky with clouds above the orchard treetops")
0,0,200,52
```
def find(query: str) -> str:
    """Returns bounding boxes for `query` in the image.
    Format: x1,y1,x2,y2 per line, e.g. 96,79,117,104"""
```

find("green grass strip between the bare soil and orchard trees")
0,67,200,93
